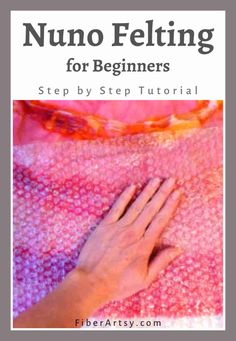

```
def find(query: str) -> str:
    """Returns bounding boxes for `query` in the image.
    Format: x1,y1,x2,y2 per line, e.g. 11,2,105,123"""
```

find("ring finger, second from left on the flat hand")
121,178,160,225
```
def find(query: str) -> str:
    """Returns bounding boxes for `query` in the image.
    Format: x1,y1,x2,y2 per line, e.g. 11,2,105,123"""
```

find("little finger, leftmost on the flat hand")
103,185,136,224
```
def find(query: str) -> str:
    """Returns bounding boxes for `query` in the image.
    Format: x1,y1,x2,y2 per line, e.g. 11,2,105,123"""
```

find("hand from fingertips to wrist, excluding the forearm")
77,179,181,303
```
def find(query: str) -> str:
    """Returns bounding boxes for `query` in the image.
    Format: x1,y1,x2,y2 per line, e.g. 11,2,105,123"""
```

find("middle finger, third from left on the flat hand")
135,178,175,232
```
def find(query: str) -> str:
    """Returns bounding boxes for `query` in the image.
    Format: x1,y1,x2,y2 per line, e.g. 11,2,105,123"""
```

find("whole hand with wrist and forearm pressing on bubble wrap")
14,179,181,328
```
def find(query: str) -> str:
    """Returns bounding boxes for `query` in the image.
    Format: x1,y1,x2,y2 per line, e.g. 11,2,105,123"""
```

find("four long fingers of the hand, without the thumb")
103,178,180,238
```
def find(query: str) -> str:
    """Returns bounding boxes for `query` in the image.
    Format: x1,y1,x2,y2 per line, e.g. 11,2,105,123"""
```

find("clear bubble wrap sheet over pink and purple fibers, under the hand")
13,127,223,326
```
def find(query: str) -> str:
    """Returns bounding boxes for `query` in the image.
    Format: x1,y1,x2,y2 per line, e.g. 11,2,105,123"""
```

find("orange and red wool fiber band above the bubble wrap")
14,100,222,140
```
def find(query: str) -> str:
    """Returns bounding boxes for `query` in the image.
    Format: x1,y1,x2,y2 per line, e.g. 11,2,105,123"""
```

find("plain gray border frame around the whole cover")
0,0,236,341
